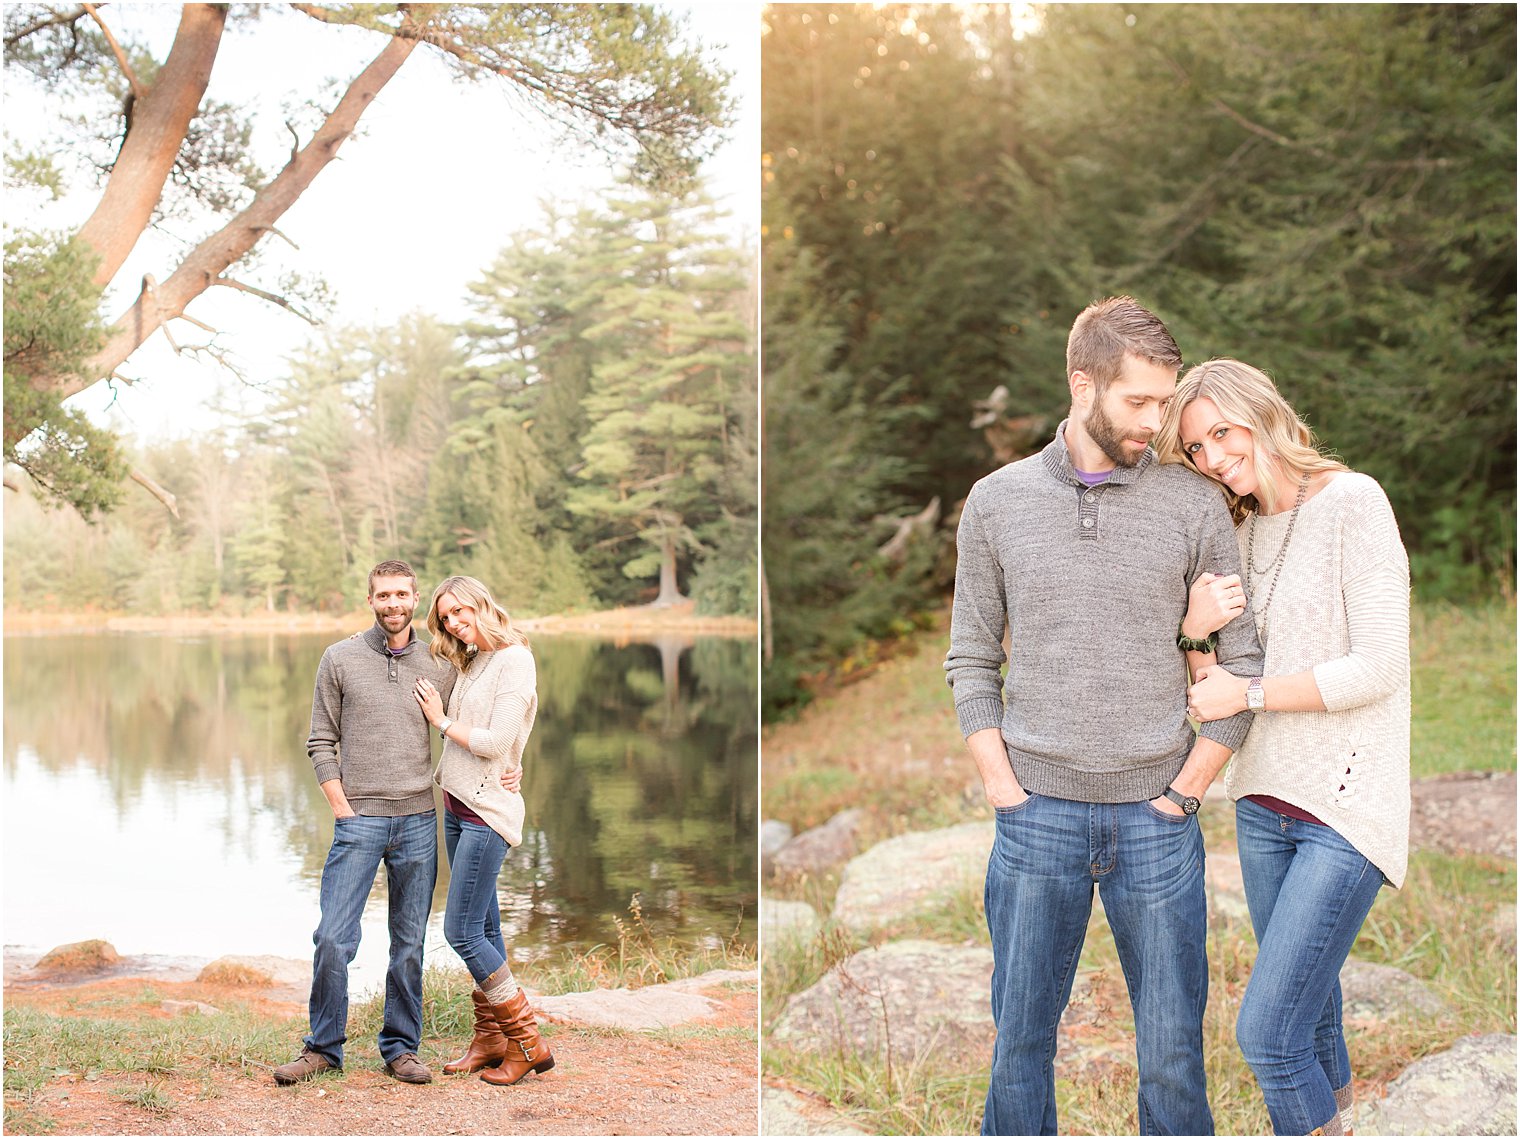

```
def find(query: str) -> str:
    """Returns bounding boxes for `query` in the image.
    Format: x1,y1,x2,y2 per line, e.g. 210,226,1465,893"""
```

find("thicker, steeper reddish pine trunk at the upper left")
79,5,226,287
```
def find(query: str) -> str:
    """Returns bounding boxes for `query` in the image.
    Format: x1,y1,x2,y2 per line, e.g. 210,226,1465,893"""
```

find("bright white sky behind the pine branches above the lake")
5,3,760,441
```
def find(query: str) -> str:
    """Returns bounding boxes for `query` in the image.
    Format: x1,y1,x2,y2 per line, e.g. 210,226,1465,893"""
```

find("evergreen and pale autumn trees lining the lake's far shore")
6,186,755,614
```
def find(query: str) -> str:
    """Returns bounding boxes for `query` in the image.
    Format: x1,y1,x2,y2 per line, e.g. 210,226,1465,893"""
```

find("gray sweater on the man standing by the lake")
306,622,459,818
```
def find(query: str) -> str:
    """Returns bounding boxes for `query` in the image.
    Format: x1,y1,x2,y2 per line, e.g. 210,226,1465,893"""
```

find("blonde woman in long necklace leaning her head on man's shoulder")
1157,359,1409,1134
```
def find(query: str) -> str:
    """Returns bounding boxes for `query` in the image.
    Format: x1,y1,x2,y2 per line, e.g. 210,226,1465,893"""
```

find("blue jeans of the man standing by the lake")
306,811,438,1068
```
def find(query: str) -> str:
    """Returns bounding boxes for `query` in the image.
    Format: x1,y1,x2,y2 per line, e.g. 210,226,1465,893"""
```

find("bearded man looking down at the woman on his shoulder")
945,297,1262,1134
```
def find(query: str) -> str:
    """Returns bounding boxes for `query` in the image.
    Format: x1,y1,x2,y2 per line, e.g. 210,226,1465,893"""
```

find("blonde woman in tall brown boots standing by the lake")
415,576,555,1084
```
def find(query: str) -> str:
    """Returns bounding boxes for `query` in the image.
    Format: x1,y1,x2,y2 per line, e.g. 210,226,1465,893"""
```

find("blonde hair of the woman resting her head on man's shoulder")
1155,357,1347,523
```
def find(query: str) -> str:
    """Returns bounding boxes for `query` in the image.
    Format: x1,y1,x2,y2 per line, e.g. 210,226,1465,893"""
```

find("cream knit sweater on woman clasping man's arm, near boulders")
1225,471,1409,887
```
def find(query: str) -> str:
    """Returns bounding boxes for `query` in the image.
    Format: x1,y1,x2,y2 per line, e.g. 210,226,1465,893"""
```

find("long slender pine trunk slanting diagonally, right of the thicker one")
56,36,416,397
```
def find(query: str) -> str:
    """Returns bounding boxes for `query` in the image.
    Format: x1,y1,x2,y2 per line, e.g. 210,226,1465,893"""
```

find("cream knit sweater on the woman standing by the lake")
433,645,538,847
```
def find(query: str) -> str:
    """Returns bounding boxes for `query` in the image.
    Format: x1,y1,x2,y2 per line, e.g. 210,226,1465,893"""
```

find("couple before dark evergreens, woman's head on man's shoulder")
945,297,1409,1134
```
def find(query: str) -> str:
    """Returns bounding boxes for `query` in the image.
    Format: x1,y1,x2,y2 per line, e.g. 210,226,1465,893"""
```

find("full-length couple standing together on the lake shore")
274,561,555,1084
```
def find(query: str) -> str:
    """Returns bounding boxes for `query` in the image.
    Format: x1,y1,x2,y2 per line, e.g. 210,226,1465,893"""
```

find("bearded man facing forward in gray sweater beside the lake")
275,561,456,1084
